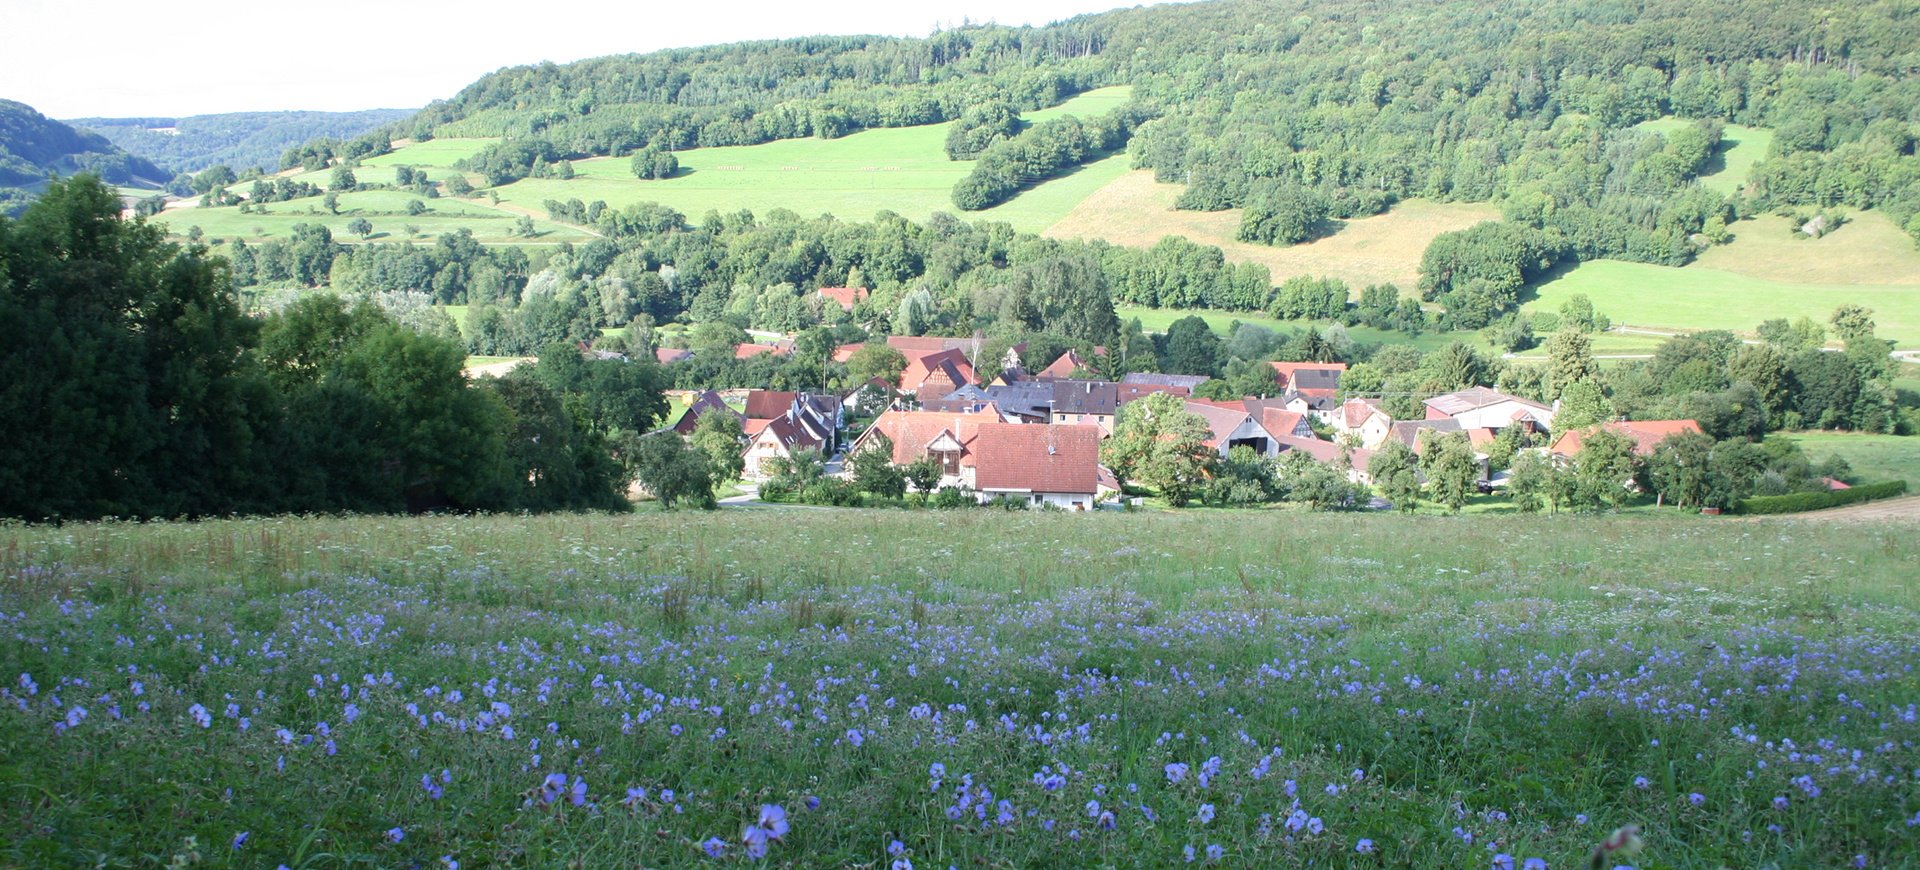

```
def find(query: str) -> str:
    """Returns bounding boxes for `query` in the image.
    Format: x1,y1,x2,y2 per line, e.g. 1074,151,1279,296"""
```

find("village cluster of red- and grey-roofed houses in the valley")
648,332,1699,511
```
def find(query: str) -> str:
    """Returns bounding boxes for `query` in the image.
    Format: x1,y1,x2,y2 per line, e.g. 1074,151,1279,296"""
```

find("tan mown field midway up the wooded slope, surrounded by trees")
1046,169,1500,294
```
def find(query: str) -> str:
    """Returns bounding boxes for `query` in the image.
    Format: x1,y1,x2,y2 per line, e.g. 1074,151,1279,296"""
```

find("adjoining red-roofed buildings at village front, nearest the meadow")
849,411,1100,511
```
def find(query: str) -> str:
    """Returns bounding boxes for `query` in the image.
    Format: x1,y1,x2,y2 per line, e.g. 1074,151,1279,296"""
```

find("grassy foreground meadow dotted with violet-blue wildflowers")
0,509,1920,870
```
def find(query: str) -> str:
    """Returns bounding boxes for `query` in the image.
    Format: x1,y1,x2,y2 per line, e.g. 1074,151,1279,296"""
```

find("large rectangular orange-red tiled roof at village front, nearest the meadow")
973,423,1100,494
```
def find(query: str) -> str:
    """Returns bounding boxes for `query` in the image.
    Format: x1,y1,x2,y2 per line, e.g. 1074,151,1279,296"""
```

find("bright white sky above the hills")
0,0,1125,117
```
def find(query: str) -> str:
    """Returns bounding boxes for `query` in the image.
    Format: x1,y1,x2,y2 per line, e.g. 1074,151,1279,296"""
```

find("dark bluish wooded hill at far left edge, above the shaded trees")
0,100,165,215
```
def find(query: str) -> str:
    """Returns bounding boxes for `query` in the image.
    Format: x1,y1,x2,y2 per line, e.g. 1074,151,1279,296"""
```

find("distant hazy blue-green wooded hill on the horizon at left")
67,109,413,175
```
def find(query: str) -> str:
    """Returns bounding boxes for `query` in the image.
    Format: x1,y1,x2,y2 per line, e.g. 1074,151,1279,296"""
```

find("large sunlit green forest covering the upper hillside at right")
311,0,1920,328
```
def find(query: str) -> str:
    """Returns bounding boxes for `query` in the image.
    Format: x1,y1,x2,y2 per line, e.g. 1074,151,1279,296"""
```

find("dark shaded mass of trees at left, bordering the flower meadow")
0,177,666,520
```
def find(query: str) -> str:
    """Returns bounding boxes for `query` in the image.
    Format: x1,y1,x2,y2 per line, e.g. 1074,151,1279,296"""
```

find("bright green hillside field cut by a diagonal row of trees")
487,86,1131,232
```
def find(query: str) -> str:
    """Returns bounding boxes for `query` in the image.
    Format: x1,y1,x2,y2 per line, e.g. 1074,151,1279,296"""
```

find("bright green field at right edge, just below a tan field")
1523,259,1920,348
